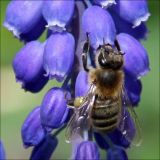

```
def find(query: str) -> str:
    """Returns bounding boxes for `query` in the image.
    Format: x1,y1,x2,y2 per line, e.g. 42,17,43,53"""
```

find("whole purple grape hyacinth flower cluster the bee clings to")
4,0,150,160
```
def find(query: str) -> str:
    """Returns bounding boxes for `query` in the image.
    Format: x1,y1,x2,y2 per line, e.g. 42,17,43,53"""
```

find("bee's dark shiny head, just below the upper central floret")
98,44,123,70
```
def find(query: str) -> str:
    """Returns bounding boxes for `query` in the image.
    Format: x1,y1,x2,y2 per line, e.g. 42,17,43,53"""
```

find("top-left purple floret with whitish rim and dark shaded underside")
4,0,46,42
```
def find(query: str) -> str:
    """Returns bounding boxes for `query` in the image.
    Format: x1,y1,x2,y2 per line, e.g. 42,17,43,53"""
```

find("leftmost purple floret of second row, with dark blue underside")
13,41,48,92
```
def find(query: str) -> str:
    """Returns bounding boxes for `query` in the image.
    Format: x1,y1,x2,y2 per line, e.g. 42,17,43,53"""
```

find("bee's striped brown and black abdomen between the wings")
91,99,121,132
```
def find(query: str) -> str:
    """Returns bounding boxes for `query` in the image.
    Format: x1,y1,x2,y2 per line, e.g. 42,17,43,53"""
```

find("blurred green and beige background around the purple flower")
0,0,160,160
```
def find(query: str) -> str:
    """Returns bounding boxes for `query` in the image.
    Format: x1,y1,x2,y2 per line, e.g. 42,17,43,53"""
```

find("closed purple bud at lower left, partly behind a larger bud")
21,107,45,148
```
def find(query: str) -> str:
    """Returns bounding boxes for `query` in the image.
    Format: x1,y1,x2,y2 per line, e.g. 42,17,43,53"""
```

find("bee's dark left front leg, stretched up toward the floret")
82,33,90,72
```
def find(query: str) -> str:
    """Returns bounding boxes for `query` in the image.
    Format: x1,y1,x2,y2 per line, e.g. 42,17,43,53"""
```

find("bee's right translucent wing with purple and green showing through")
119,87,142,146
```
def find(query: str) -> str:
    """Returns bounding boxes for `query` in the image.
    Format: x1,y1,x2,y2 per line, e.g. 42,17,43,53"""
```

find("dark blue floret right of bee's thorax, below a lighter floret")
125,74,142,106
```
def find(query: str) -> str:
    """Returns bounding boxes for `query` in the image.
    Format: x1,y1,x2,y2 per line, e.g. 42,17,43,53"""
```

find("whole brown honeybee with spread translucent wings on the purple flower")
66,34,141,146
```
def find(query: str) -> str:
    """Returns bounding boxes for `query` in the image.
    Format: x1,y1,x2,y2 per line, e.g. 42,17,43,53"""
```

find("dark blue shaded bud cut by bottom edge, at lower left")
30,135,58,160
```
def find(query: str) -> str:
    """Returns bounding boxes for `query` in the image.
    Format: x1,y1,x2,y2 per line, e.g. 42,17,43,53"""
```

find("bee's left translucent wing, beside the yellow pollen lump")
66,84,95,142
